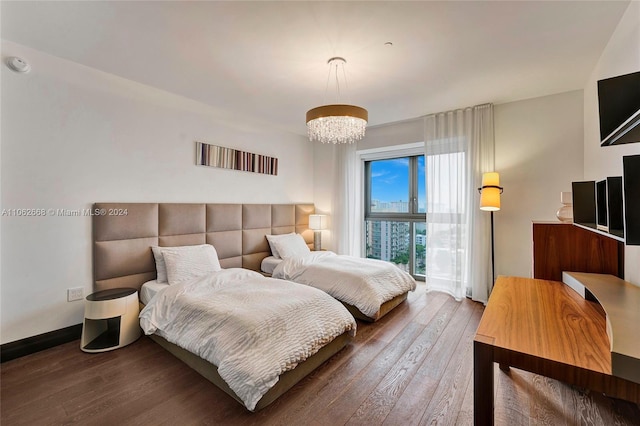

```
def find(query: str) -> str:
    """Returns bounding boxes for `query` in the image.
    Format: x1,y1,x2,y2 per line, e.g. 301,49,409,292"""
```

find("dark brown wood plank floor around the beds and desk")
0,286,640,426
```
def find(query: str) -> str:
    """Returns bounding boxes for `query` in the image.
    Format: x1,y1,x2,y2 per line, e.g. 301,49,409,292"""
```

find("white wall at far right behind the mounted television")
584,1,640,285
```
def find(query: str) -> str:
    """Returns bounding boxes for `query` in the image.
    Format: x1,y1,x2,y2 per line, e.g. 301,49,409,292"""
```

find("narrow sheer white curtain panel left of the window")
327,144,363,257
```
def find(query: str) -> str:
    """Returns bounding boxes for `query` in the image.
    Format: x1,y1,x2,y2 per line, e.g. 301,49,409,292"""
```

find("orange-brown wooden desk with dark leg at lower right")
473,276,640,425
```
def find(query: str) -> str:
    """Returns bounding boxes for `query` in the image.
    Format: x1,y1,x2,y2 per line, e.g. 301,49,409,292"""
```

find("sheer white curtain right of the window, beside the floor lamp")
425,104,494,302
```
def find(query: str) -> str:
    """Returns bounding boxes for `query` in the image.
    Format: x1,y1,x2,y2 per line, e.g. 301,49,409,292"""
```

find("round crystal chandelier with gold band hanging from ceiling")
307,57,369,144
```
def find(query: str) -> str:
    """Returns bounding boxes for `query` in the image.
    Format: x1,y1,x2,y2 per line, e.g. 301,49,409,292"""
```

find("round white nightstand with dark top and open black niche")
80,288,141,352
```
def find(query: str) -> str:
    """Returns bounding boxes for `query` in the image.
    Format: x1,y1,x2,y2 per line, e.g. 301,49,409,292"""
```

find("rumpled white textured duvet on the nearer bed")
140,269,356,410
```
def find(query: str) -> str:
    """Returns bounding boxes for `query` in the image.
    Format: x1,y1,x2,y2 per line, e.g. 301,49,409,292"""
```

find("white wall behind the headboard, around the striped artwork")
0,42,314,343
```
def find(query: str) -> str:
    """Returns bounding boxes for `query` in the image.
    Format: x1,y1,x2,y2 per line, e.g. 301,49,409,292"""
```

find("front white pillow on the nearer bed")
162,244,222,285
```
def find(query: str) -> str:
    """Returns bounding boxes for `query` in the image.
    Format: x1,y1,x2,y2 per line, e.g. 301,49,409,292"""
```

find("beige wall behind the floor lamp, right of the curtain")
494,90,583,277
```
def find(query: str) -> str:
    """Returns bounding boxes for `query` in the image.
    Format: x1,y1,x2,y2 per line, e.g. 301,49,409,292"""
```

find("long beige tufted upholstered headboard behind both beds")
93,203,314,291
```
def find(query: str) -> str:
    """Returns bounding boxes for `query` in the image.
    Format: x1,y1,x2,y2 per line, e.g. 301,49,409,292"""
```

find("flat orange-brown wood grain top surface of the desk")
476,276,611,374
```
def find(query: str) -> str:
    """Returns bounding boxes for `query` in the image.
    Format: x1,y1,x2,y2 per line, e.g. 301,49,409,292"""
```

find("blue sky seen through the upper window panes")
371,157,424,210
